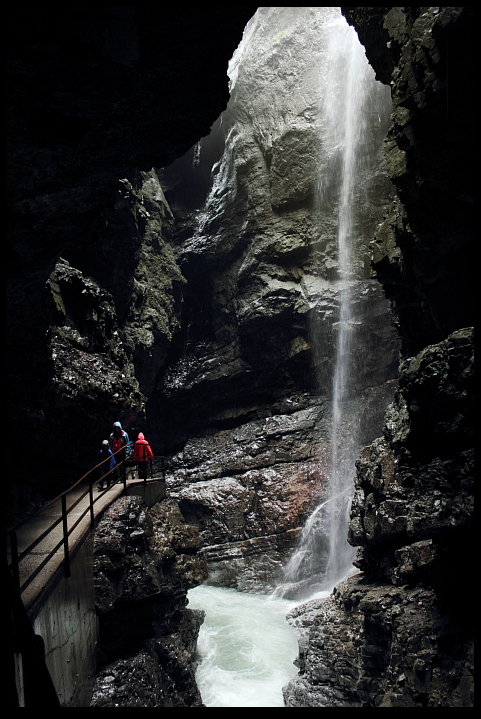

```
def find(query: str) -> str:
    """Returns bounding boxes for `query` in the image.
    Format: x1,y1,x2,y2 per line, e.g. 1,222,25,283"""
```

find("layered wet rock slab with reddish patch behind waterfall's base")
166,383,393,592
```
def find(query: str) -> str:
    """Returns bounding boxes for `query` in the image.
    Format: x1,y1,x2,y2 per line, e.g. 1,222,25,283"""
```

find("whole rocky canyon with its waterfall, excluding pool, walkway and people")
7,7,474,707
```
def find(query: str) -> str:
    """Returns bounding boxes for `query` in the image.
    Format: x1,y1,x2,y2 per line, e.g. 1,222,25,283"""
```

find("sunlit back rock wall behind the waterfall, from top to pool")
153,8,398,591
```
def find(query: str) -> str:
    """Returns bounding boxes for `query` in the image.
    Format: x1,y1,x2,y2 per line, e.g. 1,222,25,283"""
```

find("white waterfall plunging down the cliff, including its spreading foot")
277,16,390,598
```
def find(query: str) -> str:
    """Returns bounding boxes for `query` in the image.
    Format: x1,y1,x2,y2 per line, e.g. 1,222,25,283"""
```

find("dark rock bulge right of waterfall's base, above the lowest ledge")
350,329,474,597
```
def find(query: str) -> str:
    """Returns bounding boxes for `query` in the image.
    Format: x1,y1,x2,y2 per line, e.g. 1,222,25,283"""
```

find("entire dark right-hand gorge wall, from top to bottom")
285,8,474,707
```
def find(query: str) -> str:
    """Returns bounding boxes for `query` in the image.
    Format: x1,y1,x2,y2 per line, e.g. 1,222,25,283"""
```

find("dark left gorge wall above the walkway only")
8,7,255,518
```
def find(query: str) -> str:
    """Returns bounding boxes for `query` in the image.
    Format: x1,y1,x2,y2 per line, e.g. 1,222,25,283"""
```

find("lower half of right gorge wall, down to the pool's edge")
284,329,475,707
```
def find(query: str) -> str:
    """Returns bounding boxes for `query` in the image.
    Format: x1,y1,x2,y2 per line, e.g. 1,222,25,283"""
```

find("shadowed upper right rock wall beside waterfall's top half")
343,8,476,356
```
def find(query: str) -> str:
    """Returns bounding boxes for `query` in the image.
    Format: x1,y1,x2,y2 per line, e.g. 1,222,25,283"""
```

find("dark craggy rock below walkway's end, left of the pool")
91,497,207,707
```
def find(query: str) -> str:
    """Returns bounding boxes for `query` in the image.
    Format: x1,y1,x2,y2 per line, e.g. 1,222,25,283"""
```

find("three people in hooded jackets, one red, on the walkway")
98,422,154,491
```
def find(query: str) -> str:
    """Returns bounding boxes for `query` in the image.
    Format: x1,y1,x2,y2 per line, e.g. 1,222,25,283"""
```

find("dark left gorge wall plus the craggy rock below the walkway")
7,6,255,706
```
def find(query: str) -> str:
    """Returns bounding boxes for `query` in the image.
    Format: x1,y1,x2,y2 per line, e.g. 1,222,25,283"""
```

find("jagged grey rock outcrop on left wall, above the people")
40,171,185,450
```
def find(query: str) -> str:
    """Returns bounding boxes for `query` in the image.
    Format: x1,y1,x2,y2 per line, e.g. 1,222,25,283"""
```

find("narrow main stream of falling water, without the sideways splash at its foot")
320,15,375,587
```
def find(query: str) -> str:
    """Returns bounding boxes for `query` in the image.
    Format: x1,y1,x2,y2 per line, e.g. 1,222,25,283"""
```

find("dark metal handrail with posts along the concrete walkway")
7,447,165,593
